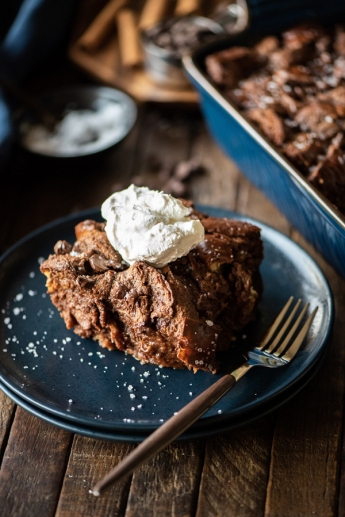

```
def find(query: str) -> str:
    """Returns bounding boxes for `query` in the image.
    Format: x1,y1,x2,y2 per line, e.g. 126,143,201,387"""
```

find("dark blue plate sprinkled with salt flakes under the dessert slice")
0,207,333,435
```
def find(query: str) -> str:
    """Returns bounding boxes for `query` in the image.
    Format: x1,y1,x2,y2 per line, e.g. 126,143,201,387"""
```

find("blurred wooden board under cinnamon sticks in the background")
69,0,222,104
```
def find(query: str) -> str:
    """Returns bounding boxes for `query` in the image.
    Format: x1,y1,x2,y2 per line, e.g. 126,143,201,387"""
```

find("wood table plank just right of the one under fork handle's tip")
125,440,204,517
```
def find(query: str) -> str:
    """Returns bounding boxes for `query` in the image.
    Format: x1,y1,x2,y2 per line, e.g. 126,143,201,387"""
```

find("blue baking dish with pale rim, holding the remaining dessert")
183,31,345,277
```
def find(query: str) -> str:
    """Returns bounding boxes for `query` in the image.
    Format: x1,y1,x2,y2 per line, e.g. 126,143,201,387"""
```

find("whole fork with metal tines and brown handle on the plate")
90,296,318,496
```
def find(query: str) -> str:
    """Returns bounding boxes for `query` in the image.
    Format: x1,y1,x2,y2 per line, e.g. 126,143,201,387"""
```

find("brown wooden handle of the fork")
91,374,236,496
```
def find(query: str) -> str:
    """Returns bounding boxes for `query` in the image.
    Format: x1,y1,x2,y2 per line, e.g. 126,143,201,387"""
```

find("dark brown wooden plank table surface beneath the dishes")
0,57,345,517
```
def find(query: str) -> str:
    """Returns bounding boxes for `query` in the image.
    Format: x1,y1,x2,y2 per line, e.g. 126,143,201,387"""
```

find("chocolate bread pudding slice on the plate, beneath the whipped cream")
41,206,263,373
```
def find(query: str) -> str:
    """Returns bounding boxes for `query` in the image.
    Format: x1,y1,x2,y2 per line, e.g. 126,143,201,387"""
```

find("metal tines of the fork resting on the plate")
256,296,318,361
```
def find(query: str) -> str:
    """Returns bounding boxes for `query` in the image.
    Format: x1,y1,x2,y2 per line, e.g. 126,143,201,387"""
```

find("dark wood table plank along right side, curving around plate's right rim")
265,233,345,517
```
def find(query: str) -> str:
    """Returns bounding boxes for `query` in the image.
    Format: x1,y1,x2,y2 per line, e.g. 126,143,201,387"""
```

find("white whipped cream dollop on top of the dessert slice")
102,185,205,267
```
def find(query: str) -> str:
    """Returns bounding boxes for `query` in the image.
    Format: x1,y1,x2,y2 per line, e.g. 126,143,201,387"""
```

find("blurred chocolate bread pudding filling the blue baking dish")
205,23,345,213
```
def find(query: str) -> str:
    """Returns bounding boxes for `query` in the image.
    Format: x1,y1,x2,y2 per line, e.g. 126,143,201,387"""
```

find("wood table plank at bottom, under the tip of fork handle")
55,436,134,517
